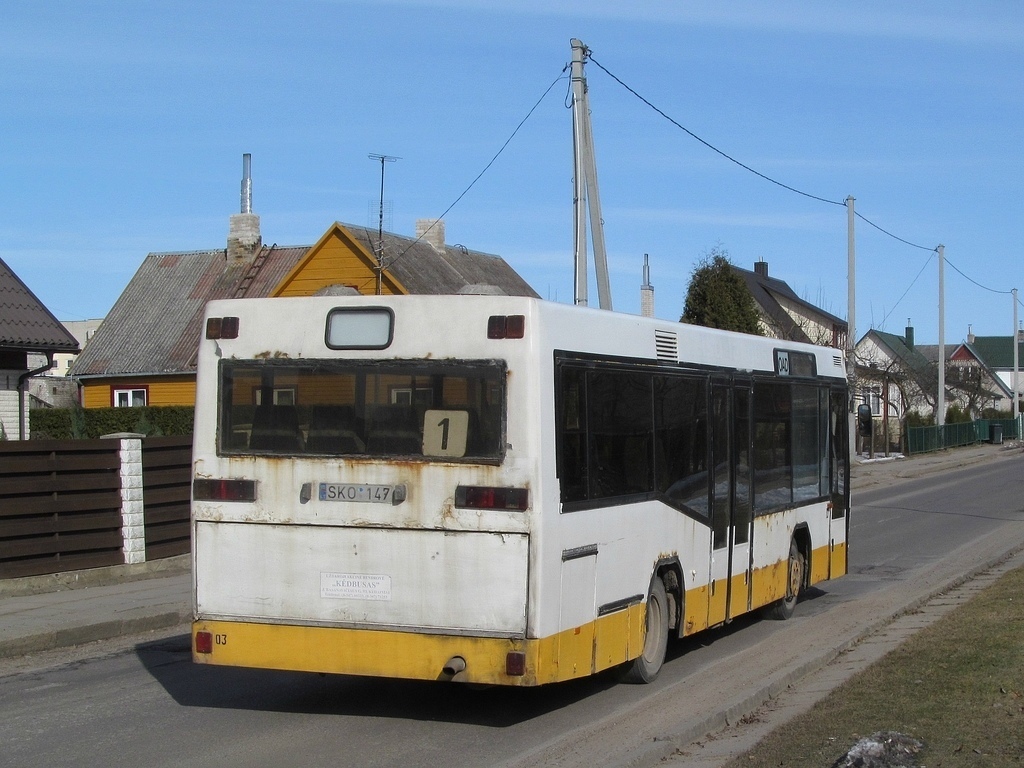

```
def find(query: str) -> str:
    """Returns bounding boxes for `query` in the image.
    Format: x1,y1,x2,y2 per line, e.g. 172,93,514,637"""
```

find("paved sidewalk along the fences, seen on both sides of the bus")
0,442,1022,658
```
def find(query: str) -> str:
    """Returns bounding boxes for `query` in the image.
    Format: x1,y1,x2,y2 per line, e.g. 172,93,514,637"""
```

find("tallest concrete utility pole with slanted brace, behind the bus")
570,38,611,309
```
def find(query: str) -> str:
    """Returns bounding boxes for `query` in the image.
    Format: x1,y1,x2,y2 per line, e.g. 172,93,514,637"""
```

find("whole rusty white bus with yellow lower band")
193,296,849,686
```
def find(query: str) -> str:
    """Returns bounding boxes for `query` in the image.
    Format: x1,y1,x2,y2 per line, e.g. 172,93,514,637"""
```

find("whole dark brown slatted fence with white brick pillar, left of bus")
0,437,191,579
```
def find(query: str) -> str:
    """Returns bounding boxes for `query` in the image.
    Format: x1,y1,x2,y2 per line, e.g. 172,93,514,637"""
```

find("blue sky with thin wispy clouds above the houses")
0,0,1024,344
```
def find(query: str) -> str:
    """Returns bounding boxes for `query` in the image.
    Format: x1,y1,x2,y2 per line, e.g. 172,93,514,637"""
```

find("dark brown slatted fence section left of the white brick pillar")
0,440,124,579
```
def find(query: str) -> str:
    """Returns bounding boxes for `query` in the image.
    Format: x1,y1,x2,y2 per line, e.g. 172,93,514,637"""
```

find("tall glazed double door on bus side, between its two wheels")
708,381,752,626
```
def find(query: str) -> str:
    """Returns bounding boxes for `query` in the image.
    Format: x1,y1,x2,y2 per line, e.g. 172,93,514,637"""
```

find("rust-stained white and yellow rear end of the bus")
193,296,540,685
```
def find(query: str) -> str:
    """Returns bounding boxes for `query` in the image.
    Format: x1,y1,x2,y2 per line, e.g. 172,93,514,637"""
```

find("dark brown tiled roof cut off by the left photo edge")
0,259,78,352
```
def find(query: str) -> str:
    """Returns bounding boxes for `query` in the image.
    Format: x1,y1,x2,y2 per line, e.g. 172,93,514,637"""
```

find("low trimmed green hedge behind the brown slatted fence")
29,406,196,440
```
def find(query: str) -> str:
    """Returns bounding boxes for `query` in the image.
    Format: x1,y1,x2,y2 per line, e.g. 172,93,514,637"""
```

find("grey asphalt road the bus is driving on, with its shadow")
0,455,1024,768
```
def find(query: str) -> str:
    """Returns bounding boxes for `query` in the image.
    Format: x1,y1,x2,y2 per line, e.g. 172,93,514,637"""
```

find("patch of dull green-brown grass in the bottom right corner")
726,568,1024,768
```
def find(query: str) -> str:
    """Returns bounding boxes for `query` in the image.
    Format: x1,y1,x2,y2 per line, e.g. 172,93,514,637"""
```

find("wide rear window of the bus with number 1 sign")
218,359,505,462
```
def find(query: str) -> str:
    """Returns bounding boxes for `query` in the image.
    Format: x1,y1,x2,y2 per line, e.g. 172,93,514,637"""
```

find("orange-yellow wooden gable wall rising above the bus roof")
272,226,408,296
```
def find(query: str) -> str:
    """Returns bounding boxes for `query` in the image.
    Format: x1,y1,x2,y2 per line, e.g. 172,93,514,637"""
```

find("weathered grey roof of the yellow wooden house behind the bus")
72,224,538,377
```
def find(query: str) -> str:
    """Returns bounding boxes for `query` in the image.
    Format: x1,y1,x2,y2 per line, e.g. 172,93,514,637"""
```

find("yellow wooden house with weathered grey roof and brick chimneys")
72,213,538,408
